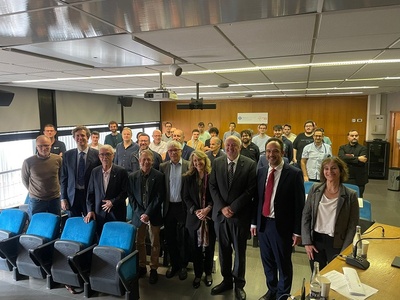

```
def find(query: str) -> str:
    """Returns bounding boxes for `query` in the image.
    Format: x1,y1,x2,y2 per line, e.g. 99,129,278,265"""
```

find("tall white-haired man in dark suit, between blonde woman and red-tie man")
210,136,256,299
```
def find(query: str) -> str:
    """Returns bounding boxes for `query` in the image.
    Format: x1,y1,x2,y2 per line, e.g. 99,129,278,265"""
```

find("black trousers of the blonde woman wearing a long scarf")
189,220,216,278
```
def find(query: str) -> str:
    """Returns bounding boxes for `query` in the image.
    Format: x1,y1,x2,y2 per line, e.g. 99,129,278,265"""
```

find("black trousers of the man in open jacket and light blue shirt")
164,202,189,270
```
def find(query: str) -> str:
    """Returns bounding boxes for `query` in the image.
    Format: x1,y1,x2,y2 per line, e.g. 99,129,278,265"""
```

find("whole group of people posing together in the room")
22,121,366,300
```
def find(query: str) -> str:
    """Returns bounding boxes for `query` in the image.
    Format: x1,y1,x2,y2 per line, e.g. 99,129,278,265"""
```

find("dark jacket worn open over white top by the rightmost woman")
301,183,360,251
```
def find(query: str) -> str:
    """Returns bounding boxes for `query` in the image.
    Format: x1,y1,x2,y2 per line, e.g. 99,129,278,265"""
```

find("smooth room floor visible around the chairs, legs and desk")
0,180,400,300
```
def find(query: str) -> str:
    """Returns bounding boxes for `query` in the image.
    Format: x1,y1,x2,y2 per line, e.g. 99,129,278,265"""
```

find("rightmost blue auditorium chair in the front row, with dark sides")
69,221,139,300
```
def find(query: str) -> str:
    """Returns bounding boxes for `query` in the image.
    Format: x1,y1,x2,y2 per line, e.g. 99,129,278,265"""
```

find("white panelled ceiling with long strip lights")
0,0,400,100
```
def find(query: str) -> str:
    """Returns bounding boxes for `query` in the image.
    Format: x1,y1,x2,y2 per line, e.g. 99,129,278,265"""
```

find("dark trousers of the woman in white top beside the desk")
310,231,341,271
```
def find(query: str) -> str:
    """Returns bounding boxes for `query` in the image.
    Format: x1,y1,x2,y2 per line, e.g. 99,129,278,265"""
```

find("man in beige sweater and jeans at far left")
21,135,62,217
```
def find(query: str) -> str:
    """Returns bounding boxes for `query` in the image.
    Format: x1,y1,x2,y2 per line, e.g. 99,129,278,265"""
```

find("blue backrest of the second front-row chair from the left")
26,213,60,241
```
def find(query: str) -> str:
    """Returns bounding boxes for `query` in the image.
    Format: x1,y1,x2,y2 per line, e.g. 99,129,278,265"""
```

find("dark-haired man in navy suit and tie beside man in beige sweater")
60,126,101,217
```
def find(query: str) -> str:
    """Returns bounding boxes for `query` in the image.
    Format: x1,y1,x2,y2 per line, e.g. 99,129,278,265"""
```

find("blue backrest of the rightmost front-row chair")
99,221,136,254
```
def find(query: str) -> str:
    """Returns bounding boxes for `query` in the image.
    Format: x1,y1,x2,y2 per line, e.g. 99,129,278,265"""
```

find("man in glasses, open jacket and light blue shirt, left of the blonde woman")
160,140,189,280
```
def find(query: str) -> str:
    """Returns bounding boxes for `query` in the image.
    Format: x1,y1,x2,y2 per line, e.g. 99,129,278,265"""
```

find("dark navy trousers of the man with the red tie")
258,217,293,299
